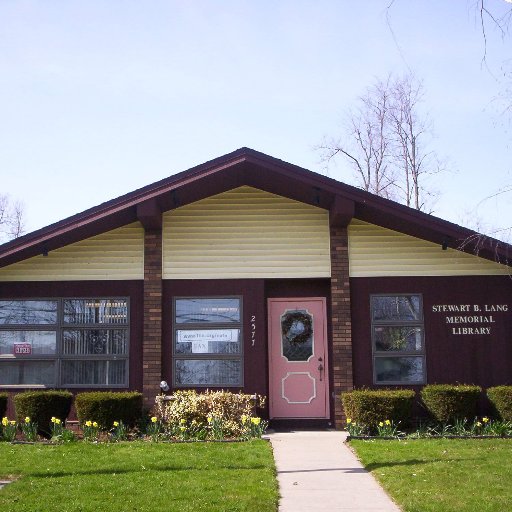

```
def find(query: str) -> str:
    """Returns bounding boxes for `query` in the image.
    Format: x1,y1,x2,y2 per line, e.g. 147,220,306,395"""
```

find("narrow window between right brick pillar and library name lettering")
370,295,425,384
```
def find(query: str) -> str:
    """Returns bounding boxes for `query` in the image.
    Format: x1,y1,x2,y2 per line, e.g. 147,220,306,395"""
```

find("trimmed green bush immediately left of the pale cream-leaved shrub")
75,391,142,430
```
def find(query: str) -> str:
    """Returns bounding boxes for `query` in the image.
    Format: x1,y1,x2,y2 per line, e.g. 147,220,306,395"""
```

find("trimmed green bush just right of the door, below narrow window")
341,389,416,431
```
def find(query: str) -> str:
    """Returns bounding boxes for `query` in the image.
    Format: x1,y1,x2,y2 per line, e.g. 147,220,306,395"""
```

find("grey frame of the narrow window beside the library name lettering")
370,293,427,386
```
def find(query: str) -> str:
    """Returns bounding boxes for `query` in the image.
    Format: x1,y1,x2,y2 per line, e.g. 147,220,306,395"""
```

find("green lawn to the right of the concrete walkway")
350,439,512,512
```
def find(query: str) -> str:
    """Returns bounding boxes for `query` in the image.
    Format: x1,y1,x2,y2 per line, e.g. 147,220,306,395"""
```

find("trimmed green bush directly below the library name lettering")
421,384,482,423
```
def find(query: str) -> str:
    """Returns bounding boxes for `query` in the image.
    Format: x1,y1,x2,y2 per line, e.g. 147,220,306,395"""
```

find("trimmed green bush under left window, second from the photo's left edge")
13,391,73,437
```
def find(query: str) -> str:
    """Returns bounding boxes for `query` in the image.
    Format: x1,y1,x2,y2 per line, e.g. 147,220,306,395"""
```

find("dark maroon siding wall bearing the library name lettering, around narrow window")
351,276,512,388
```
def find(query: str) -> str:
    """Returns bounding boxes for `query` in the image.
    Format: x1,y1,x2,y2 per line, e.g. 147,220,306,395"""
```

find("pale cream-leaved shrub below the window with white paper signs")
157,390,265,437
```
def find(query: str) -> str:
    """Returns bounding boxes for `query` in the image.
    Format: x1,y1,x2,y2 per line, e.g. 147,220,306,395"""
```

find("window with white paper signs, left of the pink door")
173,297,243,387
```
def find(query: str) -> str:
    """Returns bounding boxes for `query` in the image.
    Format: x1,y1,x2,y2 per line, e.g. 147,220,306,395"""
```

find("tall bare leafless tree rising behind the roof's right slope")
317,74,440,210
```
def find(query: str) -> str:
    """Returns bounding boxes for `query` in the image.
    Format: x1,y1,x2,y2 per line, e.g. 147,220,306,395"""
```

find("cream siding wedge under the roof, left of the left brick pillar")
0,222,144,281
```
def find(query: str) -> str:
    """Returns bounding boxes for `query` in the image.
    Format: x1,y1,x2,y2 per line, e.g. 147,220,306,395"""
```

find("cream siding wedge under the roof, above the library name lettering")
348,219,512,277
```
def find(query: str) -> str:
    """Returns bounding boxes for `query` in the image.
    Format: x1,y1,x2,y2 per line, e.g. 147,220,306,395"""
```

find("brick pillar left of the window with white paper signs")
142,228,162,408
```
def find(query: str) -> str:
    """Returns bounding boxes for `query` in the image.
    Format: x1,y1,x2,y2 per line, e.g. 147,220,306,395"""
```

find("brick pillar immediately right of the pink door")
330,226,354,428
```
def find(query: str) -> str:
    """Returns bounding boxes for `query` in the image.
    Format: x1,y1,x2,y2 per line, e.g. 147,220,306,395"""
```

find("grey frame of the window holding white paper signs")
171,295,244,389
